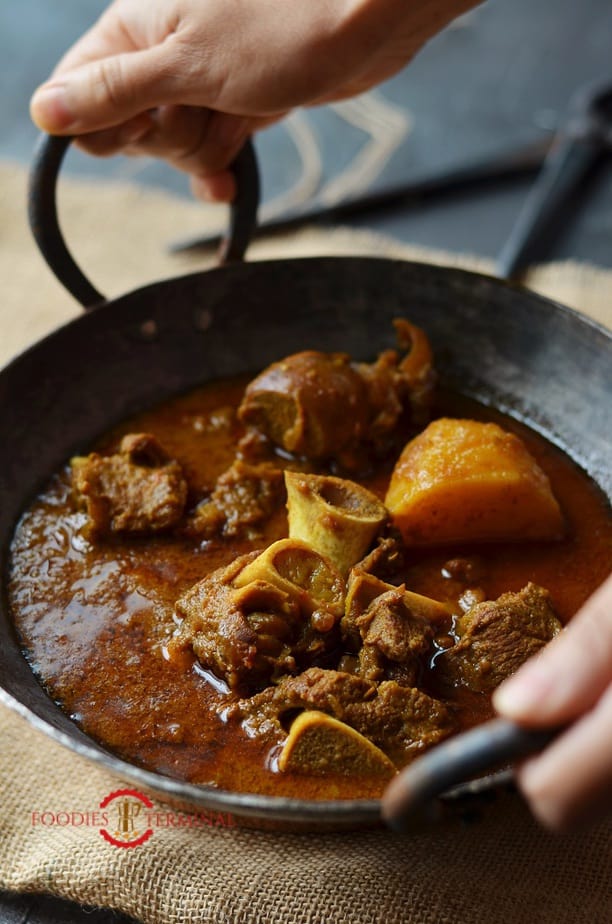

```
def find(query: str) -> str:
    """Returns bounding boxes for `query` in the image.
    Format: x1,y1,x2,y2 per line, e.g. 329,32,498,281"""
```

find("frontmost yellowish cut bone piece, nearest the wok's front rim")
278,710,397,779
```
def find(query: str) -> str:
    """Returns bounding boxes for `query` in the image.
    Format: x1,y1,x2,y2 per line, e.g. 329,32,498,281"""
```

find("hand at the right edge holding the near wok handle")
493,575,612,829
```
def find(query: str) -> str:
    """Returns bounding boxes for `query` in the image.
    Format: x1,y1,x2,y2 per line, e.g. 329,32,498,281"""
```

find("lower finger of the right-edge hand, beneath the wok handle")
517,685,612,829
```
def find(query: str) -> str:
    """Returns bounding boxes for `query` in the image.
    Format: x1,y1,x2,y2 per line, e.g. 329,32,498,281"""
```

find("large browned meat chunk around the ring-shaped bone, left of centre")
168,552,340,693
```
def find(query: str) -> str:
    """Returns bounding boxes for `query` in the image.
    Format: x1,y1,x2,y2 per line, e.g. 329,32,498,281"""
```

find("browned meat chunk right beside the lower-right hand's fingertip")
436,583,561,693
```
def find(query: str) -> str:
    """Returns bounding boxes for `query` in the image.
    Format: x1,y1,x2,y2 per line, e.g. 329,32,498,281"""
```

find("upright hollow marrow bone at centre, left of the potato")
285,471,388,576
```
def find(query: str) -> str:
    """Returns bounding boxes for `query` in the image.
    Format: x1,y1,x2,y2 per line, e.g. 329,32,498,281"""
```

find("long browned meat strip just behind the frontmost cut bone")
233,667,455,766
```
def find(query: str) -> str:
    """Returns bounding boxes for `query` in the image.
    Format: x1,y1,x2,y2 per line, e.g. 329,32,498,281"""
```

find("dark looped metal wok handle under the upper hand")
28,135,259,309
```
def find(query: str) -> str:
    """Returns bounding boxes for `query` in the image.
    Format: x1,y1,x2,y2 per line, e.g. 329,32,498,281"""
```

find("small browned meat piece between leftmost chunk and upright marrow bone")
188,459,285,539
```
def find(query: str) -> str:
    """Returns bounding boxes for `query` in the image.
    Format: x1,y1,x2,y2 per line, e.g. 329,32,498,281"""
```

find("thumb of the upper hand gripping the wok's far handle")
30,43,178,135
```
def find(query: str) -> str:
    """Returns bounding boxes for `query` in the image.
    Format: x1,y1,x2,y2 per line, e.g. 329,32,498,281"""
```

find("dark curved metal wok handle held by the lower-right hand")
381,719,562,831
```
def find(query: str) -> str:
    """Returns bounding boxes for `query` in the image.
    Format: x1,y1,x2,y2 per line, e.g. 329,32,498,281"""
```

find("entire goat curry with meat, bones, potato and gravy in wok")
9,321,612,799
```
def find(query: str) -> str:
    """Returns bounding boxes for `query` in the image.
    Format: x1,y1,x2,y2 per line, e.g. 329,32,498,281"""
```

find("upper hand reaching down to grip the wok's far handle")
31,0,480,201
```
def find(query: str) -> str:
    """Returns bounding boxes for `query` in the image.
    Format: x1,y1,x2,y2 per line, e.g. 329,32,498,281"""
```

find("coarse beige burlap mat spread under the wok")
0,165,612,924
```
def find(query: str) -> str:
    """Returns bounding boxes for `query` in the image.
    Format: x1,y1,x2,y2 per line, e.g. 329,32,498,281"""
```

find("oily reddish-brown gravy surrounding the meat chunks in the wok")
9,379,612,799
